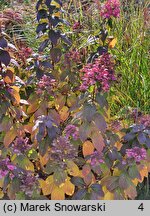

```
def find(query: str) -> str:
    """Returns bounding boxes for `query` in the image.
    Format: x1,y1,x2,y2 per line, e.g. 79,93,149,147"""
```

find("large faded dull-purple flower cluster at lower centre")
51,136,77,163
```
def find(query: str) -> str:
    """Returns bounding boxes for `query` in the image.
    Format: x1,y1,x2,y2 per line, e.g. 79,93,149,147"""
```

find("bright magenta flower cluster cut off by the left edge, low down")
0,158,16,179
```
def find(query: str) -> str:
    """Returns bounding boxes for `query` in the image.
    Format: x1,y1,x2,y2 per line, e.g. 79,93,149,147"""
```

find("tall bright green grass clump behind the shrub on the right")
110,1,150,113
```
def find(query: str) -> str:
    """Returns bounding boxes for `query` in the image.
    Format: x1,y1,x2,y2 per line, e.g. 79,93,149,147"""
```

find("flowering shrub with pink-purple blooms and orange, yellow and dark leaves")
0,0,150,200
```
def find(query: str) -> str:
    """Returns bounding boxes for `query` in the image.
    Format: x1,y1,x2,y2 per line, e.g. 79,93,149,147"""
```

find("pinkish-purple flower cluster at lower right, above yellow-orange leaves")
126,147,146,162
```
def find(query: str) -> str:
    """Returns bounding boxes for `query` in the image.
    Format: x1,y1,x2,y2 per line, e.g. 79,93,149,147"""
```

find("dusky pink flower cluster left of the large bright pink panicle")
36,75,56,95
